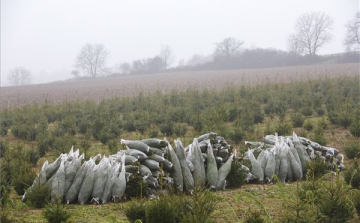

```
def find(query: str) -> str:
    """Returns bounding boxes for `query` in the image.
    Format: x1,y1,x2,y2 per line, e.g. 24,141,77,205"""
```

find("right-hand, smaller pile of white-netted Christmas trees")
245,133,345,182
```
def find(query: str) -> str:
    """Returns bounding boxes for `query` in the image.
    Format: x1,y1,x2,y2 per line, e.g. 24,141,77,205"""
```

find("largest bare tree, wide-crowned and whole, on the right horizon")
288,12,334,56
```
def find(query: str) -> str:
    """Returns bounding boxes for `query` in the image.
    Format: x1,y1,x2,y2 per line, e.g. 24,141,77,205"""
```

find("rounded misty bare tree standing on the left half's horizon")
75,44,109,78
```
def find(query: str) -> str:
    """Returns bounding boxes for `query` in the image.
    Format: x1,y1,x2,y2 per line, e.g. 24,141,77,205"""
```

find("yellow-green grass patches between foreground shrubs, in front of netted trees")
5,182,360,223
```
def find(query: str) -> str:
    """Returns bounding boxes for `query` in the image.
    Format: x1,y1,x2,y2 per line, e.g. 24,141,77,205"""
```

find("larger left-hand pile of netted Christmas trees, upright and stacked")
23,133,236,204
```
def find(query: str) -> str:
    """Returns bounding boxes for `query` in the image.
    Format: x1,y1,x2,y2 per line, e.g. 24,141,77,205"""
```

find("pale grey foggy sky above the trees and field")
0,0,359,86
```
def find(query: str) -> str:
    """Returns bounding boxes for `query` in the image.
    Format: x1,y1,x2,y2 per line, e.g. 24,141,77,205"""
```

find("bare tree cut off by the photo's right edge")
344,11,360,51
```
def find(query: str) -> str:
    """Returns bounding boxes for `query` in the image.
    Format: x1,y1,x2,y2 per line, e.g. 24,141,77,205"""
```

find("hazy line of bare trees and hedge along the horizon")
8,11,360,85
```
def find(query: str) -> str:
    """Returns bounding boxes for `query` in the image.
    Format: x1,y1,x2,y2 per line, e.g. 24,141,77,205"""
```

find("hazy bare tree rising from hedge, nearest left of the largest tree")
214,37,244,59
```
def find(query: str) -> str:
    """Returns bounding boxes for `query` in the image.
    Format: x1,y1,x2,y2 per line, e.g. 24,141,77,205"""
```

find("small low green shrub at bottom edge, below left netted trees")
43,202,71,223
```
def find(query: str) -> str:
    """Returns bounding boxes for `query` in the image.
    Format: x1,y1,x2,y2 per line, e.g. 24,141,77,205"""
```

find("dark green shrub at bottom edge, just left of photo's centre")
145,198,179,223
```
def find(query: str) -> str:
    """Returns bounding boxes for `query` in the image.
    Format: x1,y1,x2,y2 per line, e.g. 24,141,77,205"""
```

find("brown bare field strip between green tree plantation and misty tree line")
0,63,360,108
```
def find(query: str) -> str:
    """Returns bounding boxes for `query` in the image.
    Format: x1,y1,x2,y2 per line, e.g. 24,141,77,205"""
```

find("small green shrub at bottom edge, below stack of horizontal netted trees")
125,200,146,223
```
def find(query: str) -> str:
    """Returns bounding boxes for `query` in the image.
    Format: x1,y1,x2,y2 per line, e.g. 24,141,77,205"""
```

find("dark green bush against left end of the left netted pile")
26,181,51,208
